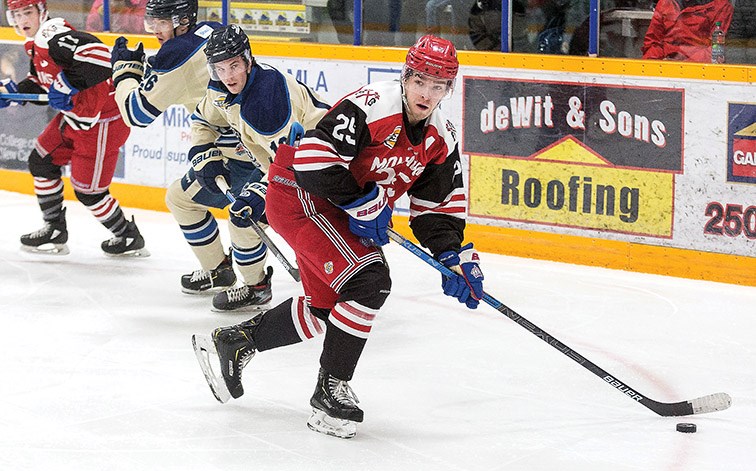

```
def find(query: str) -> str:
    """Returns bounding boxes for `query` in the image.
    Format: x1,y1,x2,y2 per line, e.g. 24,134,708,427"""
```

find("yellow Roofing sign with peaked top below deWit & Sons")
470,138,674,238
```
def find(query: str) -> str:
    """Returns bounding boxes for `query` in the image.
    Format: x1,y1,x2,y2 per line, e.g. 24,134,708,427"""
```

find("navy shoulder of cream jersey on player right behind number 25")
241,66,291,135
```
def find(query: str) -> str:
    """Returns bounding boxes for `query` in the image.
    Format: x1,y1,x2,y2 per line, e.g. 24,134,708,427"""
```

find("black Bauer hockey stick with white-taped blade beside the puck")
388,229,732,417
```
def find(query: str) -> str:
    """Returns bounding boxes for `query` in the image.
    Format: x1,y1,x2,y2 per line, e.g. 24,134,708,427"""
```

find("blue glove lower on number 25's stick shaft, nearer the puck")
438,243,483,309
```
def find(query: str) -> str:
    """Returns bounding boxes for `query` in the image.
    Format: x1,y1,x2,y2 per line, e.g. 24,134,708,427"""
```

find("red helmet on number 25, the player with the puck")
405,34,459,80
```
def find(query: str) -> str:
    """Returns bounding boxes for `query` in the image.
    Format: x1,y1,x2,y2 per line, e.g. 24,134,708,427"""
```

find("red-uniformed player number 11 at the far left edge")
0,0,149,256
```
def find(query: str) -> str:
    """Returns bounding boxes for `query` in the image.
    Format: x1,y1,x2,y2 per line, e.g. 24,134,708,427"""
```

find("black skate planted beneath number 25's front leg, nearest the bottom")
307,368,364,438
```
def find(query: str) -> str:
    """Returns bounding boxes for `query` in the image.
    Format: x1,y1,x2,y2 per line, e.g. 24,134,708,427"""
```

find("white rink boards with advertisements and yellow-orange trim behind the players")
0,28,756,286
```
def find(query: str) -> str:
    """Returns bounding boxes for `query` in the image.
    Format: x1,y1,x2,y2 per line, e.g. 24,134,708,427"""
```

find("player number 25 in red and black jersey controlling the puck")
193,35,483,438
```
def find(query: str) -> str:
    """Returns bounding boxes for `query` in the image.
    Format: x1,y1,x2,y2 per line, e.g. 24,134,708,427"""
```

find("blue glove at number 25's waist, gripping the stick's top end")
339,185,391,245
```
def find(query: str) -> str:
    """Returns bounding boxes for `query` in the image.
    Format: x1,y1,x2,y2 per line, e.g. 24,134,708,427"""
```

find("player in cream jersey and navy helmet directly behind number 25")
189,25,329,311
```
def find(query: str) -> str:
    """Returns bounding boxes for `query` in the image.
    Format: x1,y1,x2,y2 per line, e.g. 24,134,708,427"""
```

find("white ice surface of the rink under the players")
0,191,756,471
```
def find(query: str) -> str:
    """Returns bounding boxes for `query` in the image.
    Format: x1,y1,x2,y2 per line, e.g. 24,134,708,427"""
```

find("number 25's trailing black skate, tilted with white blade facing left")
192,316,259,403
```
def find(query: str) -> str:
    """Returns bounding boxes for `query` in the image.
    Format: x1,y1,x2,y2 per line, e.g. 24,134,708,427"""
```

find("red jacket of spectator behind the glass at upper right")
641,0,733,62
